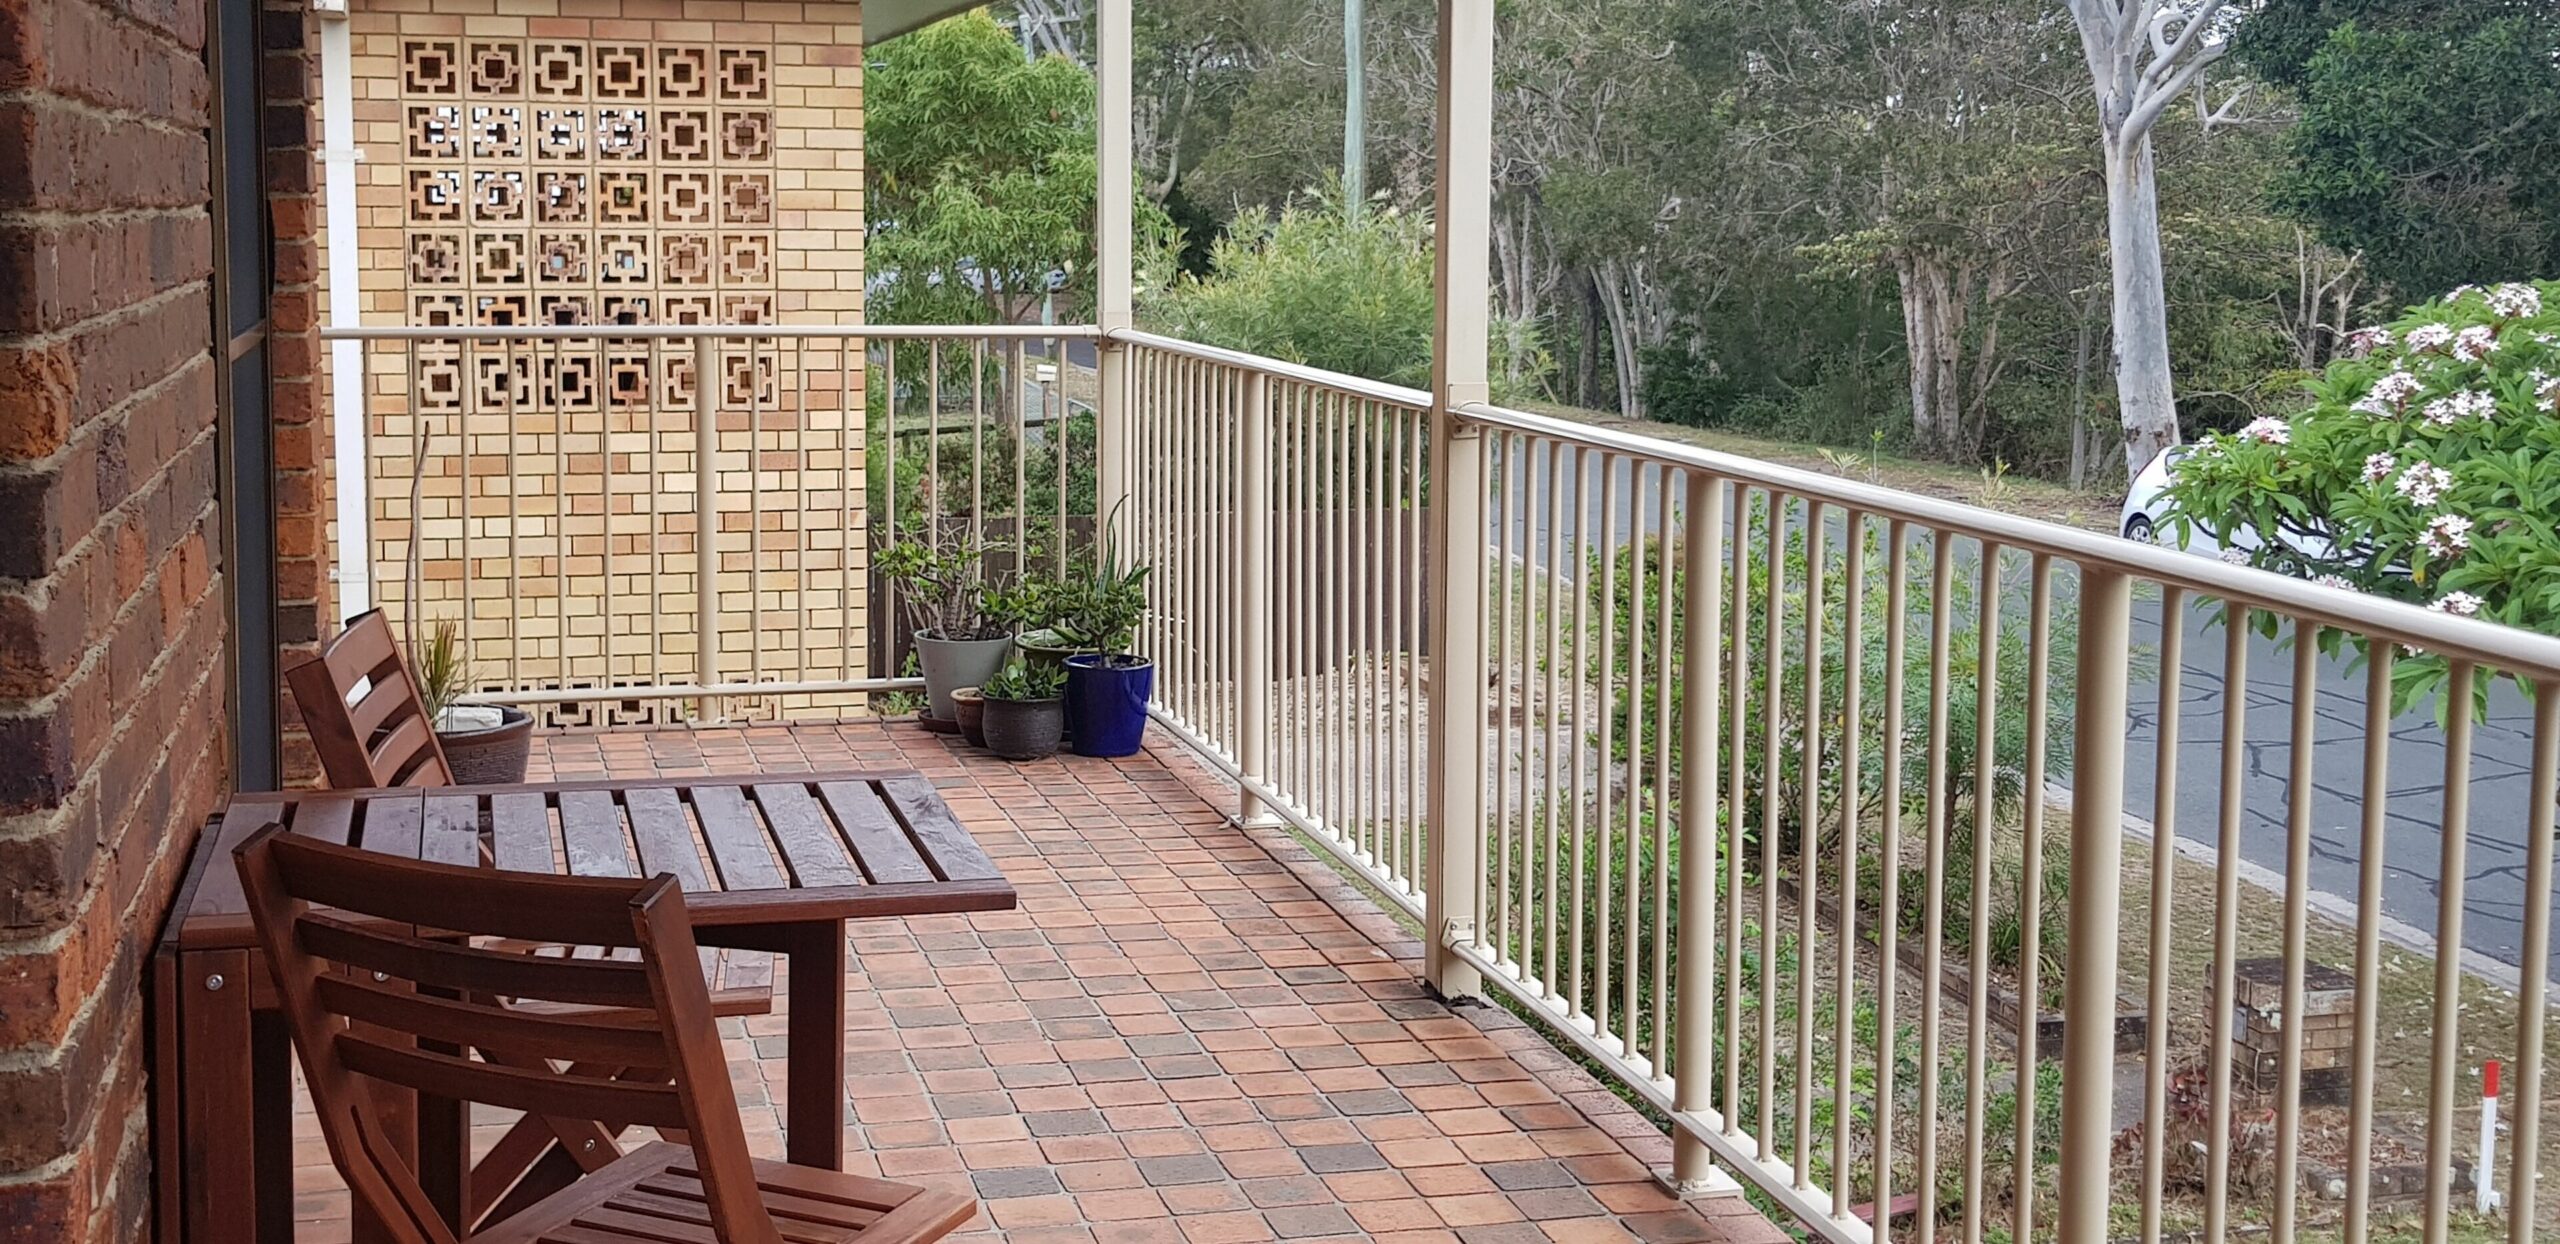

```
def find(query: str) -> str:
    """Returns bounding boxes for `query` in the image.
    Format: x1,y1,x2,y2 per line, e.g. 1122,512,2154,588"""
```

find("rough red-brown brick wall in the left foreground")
0,0,225,1241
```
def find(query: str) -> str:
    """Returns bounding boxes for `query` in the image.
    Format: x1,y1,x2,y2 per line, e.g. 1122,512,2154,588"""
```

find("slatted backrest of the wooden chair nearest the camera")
238,827,781,1244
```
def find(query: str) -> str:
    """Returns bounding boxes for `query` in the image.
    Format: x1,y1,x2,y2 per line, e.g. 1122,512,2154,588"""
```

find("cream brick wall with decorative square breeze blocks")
325,0,868,724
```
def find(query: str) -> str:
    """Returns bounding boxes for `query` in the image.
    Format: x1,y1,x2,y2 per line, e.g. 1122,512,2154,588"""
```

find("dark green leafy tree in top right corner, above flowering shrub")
2232,0,2560,302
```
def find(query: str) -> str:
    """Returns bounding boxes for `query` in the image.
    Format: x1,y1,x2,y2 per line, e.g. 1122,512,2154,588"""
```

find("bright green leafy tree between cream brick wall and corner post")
865,10,1172,323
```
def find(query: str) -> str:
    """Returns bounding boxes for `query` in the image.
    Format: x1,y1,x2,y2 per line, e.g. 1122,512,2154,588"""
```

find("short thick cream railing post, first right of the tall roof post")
1672,474,1733,1195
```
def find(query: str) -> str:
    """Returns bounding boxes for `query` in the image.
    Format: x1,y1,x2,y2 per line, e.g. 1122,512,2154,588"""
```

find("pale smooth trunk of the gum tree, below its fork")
2107,136,2179,481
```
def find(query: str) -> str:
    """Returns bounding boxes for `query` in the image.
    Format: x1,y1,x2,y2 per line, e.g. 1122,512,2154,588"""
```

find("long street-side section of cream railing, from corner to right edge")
1114,333,2560,1241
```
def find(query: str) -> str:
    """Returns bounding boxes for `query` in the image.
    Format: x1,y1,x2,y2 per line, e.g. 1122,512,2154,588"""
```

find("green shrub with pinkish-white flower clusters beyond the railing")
2166,284,2560,704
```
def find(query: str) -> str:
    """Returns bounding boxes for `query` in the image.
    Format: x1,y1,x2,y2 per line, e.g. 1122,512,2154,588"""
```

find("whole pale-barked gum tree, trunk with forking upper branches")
2063,0,2240,479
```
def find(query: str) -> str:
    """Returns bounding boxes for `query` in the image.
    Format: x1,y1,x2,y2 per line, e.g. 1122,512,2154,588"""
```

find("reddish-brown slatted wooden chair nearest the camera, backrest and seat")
238,827,975,1244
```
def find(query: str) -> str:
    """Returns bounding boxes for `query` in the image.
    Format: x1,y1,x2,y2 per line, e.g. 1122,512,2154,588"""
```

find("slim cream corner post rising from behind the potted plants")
1090,0,1137,555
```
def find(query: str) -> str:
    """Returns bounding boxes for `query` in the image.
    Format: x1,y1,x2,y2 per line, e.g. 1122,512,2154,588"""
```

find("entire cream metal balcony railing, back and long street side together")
335,316,2560,1241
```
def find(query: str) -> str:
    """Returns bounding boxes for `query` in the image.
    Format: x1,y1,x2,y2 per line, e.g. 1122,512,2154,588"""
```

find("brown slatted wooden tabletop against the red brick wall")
179,773,1014,950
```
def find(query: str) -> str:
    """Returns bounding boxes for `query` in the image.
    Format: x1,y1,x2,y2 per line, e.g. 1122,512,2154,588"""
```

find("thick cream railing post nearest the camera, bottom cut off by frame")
2056,566,2132,1244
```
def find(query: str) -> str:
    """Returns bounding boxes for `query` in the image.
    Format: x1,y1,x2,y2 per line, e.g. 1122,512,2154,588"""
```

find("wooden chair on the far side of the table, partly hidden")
284,609,773,1224
